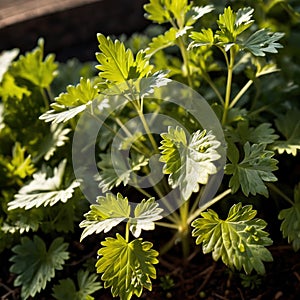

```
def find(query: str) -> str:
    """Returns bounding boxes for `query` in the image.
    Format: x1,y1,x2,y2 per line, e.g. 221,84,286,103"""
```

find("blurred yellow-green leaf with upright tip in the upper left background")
12,39,57,88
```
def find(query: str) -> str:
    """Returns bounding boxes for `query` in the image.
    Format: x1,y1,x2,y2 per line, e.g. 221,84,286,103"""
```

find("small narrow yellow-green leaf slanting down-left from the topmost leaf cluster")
145,27,177,57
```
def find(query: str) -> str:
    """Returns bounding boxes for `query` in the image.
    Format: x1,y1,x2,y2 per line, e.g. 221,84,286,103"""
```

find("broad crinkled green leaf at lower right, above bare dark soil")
192,203,272,274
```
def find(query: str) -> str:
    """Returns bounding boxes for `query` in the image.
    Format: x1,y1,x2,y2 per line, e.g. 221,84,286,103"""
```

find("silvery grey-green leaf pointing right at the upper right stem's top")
239,28,284,56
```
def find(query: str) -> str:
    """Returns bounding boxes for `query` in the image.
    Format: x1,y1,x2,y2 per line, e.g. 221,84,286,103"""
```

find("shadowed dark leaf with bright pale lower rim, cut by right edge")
273,109,300,156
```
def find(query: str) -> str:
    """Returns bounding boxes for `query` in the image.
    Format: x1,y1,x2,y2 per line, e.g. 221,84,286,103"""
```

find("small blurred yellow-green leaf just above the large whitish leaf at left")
6,142,36,179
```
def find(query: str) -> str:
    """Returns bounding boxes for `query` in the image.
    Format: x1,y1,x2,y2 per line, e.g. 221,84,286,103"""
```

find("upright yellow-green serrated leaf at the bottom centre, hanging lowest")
96,233,158,300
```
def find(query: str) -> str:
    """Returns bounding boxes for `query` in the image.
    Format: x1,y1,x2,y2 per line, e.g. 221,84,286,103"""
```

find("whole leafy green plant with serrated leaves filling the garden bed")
0,0,300,299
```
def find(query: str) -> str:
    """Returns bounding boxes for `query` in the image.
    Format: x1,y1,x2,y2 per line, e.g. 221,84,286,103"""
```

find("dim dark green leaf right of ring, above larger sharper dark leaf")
229,121,279,145
